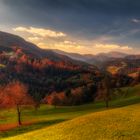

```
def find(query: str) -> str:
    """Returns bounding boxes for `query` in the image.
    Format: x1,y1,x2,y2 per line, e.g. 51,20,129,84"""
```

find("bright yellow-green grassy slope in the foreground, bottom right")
3,104,140,140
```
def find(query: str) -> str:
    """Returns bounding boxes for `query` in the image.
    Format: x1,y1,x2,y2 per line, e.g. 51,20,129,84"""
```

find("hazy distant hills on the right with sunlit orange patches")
53,50,140,78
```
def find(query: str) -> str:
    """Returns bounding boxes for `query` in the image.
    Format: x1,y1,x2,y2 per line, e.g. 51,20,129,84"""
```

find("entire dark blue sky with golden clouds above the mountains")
0,0,140,54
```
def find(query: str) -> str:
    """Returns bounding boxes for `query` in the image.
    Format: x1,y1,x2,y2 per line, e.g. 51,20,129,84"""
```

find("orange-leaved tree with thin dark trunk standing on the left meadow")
0,81,34,125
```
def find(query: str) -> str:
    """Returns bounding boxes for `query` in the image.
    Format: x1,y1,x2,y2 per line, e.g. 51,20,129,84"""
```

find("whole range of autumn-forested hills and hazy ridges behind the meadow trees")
0,32,140,105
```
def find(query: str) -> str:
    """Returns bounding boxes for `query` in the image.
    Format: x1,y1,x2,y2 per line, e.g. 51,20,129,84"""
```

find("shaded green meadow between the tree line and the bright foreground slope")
0,85,140,139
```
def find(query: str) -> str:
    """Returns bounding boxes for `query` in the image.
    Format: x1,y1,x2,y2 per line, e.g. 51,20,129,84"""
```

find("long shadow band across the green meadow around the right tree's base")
25,96,140,116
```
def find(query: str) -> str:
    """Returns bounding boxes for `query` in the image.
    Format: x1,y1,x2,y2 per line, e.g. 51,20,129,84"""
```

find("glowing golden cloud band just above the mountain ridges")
13,27,135,54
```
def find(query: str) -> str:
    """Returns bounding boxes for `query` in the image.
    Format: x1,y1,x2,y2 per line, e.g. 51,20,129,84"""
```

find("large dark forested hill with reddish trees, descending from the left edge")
0,32,99,105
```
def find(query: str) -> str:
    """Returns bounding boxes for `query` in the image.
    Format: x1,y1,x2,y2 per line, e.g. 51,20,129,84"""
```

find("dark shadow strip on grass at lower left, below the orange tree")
0,119,66,138
